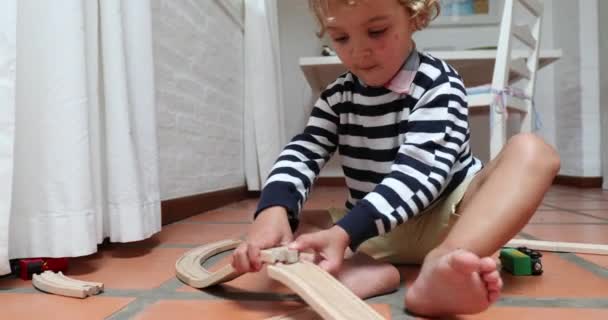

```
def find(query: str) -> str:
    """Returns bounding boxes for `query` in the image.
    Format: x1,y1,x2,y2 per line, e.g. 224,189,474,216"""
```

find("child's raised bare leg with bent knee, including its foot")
406,134,559,315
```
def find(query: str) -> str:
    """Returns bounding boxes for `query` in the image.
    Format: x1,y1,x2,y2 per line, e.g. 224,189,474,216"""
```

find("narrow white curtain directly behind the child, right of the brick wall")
244,0,284,190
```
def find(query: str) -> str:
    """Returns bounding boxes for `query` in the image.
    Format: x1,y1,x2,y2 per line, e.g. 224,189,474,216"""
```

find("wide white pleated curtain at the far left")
0,0,161,274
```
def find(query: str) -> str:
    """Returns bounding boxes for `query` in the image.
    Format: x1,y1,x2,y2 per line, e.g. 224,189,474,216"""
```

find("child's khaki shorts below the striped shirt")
329,177,474,264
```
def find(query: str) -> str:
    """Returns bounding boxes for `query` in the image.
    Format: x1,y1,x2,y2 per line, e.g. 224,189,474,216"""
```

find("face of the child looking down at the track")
325,0,416,86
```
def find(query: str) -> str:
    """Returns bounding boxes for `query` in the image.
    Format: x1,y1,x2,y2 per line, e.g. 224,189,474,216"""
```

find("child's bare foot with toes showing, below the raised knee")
405,250,502,317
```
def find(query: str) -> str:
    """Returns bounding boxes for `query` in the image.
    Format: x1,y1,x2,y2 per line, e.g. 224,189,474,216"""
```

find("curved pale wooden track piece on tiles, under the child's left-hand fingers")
175,239,241,289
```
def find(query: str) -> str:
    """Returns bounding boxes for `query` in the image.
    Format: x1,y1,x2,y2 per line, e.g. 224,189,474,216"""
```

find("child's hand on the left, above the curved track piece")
232,207,293,273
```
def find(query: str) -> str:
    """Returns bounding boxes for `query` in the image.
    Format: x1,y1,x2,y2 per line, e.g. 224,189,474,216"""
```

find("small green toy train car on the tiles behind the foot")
498,247,543,276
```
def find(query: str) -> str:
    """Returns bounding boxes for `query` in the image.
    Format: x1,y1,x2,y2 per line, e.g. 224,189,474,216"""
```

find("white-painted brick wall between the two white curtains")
152,0,245,200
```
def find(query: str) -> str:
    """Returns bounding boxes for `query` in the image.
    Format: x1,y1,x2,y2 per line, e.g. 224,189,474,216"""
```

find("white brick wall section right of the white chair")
553,0,601,177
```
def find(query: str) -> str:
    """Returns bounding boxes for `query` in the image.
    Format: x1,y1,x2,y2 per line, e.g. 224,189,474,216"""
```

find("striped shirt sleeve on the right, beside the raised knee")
337,64,468,250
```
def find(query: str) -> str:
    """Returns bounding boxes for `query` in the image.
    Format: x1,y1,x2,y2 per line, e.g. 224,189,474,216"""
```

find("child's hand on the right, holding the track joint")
289,226,350,274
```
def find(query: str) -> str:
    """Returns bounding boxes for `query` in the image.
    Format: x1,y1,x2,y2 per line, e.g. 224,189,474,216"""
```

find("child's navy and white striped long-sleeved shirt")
256,50,482,250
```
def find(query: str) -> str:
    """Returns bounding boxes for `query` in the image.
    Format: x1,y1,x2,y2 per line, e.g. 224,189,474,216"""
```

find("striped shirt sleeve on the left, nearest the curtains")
255,84,341,225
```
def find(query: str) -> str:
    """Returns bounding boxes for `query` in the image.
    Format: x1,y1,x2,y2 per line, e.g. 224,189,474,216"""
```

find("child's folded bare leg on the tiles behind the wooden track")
294,211,400,298
